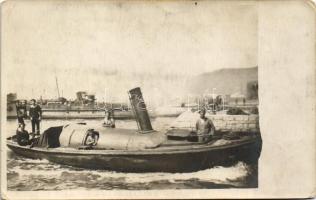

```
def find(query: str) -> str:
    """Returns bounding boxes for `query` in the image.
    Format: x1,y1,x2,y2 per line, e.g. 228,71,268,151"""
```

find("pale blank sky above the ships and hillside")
1,0,258,103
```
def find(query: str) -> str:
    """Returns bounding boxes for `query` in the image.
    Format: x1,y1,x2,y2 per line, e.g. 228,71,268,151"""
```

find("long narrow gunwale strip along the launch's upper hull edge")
7,136,258,156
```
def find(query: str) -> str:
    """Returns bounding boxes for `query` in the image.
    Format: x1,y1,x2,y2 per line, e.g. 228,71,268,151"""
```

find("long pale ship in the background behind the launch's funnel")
7,91,185,119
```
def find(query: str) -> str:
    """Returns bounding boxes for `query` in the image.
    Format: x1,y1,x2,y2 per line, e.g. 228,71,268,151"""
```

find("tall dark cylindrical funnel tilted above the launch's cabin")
128,87,153,133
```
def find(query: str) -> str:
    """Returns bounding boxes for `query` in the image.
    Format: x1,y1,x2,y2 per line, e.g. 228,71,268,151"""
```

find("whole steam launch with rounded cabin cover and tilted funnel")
7,88,261,172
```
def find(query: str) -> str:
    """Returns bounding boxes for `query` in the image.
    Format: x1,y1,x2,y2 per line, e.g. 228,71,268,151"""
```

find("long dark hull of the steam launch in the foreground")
7,137,261,172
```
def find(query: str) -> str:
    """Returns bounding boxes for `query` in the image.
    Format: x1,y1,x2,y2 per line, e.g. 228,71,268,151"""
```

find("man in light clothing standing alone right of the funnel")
196,108,215,142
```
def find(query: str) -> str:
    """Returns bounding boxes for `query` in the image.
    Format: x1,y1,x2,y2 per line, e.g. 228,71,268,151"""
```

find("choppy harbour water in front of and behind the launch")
7,118,257,191
